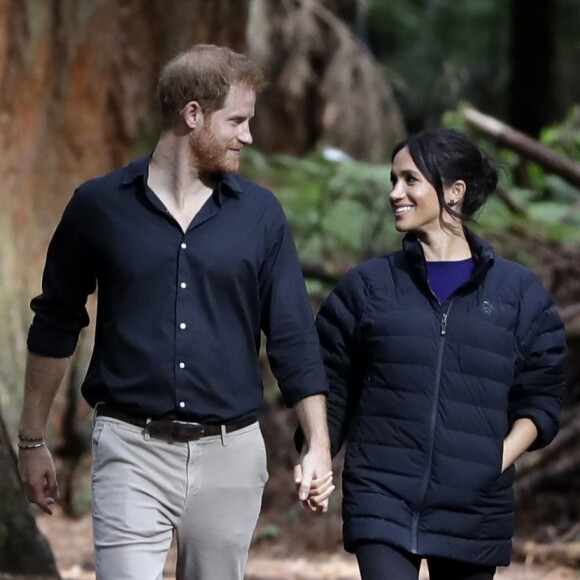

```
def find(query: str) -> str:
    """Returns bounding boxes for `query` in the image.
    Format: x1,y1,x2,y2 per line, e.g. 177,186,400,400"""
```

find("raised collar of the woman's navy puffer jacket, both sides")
403,228,495,295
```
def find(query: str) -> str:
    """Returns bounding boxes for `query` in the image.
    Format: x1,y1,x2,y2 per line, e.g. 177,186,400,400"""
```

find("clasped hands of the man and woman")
294,450,336,513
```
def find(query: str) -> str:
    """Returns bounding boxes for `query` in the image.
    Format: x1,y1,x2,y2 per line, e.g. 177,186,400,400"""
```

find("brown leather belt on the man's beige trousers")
95,404,257,443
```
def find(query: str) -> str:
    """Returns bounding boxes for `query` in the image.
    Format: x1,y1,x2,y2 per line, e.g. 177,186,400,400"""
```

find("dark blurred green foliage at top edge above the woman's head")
367,0,509,130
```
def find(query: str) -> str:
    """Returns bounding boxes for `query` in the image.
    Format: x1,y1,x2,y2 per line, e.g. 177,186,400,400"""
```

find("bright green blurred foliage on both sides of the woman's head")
243,112,580,280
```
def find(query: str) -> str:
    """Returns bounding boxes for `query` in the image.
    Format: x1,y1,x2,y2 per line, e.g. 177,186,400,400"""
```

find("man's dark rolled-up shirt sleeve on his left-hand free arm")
28,191,96,358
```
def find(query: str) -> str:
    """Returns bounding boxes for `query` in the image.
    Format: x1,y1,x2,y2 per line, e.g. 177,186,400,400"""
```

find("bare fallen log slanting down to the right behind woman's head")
463,107,580,189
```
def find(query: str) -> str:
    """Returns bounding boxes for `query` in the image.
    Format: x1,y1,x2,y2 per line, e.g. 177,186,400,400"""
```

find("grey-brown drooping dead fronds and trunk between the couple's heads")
248,0,405,162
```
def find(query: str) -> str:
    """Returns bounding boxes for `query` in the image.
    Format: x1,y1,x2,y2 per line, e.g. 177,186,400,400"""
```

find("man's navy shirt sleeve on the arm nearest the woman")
259,208,328,406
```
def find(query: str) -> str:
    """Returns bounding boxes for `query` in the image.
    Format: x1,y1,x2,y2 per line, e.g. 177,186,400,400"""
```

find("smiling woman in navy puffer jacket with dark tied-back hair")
317,129,565,580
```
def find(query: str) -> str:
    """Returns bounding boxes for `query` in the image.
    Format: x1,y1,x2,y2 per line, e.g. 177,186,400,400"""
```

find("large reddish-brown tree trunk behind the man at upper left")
0,0,249,244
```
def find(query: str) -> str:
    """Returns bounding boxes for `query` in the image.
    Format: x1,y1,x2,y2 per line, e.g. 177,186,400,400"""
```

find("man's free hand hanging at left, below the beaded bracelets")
18,446,59,515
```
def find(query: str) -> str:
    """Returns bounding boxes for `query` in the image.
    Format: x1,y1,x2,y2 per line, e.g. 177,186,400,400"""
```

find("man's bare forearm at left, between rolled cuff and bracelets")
19,352,69,437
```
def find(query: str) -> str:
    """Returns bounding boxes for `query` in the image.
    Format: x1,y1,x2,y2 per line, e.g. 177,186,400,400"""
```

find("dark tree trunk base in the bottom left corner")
0,414,60,578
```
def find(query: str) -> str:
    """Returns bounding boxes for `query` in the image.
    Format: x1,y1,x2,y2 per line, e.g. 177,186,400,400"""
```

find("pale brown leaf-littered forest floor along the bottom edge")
37,512,580,580
